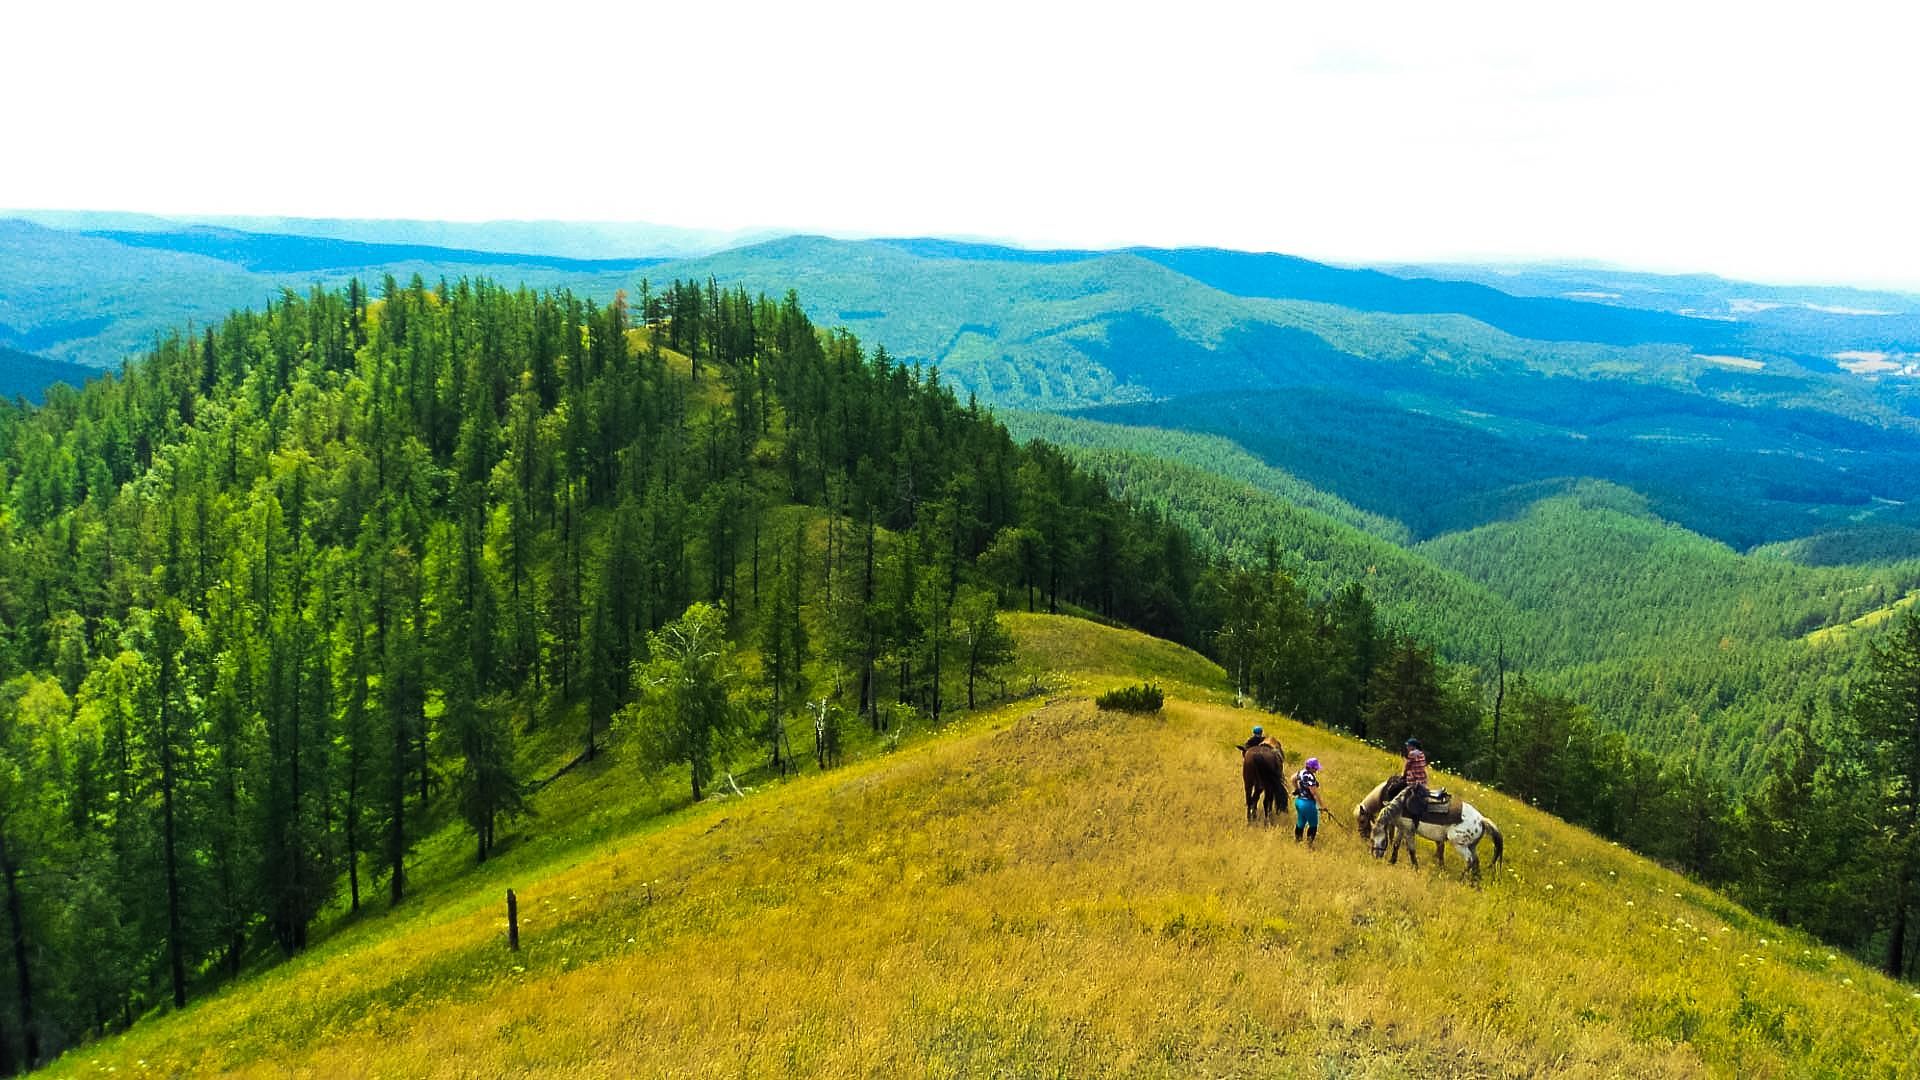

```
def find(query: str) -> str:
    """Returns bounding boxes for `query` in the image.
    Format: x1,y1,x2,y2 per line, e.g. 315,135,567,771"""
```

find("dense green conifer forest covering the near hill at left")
0,277,1206,1072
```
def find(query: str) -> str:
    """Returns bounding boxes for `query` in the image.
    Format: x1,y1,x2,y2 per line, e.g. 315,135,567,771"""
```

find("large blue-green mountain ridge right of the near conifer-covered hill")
649,238,1920,553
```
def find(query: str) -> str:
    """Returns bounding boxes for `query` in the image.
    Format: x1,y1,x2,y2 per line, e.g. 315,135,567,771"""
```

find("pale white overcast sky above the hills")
11,0,1920,290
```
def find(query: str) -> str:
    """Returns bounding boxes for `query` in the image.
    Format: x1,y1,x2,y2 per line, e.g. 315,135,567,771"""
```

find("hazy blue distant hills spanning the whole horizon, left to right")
15,219,1920,548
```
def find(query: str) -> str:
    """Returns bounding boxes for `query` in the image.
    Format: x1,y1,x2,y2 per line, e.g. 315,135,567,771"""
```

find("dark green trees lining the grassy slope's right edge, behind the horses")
1208,550,1920,978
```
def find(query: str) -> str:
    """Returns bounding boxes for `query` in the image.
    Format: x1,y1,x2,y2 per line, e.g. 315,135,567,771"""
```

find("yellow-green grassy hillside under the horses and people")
37,617,1920,1076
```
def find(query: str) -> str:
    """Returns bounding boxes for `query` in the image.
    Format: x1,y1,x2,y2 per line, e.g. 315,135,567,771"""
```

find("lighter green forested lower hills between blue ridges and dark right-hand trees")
1006,405,1920,776
